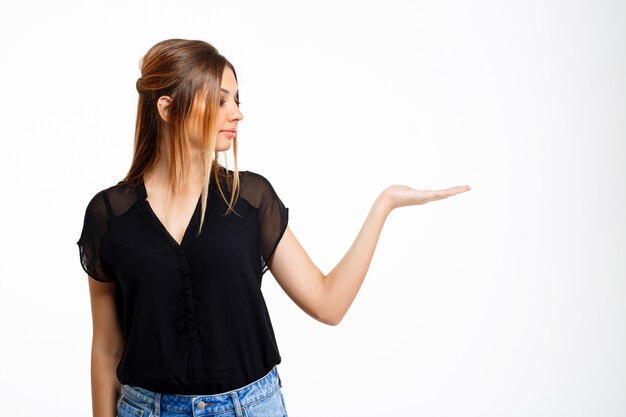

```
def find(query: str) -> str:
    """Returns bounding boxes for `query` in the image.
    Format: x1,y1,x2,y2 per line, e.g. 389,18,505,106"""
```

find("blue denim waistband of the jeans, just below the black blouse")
122,366,282,416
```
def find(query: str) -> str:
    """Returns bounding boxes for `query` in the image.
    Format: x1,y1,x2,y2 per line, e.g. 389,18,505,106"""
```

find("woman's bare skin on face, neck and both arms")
88,67,470,417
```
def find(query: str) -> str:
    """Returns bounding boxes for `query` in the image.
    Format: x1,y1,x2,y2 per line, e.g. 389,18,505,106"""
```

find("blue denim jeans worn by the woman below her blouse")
117,367,287,417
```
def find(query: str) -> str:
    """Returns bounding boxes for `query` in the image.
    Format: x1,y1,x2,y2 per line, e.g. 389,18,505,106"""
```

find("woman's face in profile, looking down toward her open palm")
189,66,243,152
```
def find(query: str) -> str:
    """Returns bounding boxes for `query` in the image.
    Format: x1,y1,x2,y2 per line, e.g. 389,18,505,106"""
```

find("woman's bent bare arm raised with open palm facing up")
268,185,470,326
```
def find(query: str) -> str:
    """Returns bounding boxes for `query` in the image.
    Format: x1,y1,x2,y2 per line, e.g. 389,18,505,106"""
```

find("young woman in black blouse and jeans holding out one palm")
77,39,469,417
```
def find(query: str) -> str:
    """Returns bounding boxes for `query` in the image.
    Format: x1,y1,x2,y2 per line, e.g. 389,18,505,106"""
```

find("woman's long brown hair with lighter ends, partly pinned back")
122,39,239,233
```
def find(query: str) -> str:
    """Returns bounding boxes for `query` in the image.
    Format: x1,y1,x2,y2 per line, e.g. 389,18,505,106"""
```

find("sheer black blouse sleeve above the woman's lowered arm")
76,191,115,282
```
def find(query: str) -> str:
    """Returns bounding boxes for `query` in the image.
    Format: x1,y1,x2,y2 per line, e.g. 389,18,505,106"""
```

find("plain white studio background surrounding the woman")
0,0,626,417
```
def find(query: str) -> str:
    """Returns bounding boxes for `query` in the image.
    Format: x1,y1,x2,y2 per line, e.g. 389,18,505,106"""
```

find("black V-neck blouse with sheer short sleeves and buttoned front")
77,171,288,395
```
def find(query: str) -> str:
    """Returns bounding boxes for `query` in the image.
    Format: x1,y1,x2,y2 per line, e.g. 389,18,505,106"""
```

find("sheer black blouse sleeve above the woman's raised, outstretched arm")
241,171,289,274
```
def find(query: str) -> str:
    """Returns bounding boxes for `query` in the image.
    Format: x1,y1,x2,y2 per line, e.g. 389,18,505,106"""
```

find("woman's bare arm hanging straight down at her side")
89,277,124,417
